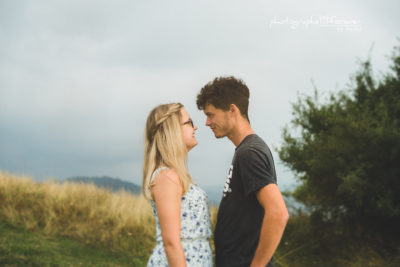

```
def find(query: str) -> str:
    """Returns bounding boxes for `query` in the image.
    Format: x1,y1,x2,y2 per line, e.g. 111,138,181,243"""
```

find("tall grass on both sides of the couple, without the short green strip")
0,171,400,267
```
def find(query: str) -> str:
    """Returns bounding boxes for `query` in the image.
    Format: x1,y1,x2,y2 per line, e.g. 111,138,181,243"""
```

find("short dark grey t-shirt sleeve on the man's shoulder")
237,148,276,196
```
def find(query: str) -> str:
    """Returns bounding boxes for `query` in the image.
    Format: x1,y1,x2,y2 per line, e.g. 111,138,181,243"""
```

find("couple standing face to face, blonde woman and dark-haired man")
143,77,289,267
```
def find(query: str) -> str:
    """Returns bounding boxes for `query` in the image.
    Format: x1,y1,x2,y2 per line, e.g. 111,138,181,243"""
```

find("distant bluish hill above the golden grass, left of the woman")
65,176,141,195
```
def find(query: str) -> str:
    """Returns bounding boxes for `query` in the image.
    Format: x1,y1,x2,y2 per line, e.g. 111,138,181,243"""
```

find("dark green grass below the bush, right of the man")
274,211,400,267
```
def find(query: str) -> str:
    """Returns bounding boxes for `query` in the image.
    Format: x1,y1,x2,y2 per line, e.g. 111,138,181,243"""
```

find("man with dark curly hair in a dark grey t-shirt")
197,77,289,267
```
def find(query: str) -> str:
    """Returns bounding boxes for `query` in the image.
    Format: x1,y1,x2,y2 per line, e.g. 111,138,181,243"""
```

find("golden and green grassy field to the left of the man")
0,171,217,266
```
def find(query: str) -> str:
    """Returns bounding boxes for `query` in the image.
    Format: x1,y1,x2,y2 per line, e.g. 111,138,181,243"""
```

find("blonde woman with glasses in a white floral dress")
142,103,212,267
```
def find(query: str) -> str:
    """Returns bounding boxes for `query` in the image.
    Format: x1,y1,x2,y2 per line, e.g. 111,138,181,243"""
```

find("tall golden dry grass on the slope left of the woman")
0,171,155,258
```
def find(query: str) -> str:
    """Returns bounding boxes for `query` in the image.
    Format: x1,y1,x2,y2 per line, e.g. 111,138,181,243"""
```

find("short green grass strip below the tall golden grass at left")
0,222,138,266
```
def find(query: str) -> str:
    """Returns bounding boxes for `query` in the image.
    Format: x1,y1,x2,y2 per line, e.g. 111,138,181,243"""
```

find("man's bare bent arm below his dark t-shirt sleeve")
250,184,289,267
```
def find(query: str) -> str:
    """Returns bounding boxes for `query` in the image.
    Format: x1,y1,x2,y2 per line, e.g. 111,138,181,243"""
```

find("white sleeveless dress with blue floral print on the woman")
147,167,213,267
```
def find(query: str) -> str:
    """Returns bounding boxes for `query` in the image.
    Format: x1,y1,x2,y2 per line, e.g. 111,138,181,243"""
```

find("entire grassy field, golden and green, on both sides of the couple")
0,171,400,267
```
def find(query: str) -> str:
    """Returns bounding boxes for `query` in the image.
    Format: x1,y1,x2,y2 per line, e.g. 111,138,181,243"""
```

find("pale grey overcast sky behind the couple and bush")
0,0,400,192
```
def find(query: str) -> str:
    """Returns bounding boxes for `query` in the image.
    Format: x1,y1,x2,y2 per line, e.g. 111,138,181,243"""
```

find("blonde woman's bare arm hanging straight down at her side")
151,169,186,267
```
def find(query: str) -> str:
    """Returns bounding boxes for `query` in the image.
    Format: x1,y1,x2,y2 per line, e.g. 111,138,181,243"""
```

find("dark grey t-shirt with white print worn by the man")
214,134,276,267
